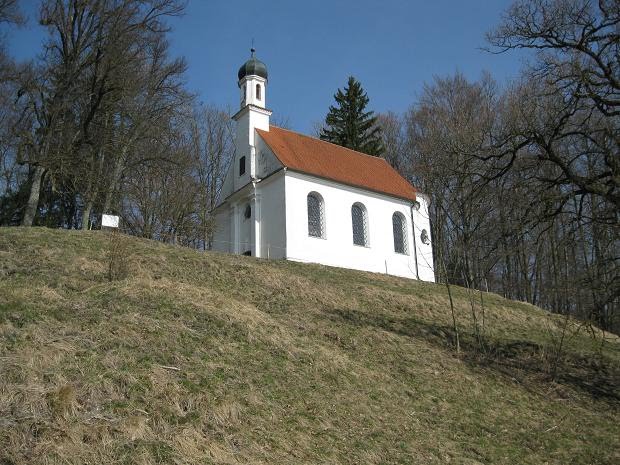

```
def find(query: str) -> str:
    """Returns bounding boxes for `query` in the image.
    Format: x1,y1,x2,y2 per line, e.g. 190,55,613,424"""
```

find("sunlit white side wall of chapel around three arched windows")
285,171,434,281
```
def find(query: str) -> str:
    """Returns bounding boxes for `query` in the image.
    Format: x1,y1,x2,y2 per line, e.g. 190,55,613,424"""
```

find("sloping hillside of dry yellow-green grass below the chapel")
0,228,620,465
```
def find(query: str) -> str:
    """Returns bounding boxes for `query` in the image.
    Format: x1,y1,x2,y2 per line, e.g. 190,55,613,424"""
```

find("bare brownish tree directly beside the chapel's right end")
407,74,496,285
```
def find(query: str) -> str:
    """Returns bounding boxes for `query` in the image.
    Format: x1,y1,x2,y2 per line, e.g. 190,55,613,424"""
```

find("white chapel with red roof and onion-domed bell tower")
213,49,435,281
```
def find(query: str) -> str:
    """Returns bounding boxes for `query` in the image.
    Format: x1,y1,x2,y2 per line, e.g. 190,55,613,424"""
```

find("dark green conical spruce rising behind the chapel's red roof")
320,76,384,156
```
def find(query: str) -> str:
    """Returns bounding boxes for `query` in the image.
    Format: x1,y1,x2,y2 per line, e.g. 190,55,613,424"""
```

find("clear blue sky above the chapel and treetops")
7,0,523,133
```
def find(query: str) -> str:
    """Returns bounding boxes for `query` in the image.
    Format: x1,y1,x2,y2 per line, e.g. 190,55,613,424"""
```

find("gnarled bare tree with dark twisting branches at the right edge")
484,0,620,328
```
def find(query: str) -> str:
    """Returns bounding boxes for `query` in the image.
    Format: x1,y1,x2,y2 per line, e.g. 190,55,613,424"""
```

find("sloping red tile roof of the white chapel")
256,126,416,200
